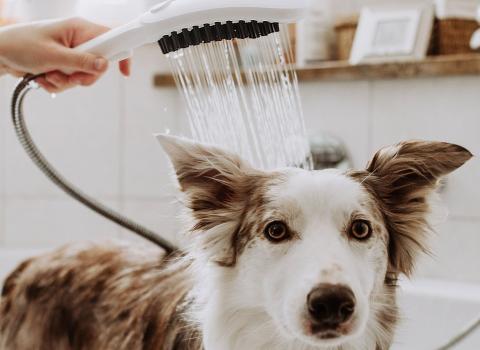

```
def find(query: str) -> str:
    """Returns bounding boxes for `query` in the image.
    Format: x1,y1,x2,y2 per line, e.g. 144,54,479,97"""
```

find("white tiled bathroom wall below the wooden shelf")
0,47,480,283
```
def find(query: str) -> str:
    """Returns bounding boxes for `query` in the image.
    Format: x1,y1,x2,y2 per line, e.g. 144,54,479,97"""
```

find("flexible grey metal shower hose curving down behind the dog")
8,75,480,350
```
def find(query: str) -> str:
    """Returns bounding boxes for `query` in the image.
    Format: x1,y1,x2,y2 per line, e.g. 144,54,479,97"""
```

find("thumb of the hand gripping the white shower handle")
51,48,108,74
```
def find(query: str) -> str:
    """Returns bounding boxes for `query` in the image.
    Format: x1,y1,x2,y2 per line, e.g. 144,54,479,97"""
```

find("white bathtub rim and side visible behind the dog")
0,250,480,350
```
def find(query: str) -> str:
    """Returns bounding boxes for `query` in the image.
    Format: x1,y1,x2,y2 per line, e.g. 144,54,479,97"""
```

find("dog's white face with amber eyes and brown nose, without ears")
237,170,388,346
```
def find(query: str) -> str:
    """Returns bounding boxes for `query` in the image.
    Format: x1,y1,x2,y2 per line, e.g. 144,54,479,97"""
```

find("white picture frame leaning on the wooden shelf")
350,3,434,65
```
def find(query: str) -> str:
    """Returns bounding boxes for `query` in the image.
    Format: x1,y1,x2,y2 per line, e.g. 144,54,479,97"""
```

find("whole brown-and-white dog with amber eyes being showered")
0,136,472,350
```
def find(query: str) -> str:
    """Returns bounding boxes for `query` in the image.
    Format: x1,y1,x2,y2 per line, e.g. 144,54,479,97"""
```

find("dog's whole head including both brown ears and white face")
160,136,472,347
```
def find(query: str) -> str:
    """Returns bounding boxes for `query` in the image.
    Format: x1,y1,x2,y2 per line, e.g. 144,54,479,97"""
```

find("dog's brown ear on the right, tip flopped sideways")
363,141,472,276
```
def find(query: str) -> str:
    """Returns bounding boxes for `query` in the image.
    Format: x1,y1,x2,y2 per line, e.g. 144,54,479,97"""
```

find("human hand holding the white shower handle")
0,18,130,93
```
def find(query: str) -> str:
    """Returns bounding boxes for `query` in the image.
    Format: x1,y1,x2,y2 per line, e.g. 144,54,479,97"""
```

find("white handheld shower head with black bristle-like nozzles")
77,0,308,61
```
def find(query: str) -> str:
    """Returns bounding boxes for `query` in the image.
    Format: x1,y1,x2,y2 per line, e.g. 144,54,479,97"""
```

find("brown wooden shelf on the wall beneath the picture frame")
154,54,480,87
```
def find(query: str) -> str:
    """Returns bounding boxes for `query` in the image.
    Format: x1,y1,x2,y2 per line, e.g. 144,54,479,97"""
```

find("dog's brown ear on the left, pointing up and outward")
164,138,280,267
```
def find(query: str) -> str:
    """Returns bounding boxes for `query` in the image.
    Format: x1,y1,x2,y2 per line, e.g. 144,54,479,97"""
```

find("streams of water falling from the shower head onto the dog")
168,27,311,169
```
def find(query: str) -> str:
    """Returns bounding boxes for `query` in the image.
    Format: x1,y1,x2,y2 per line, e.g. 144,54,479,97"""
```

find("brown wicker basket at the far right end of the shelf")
431,18,479,55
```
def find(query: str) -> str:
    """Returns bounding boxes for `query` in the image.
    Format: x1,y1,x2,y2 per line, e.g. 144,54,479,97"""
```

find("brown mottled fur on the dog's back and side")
0,246,201,350
